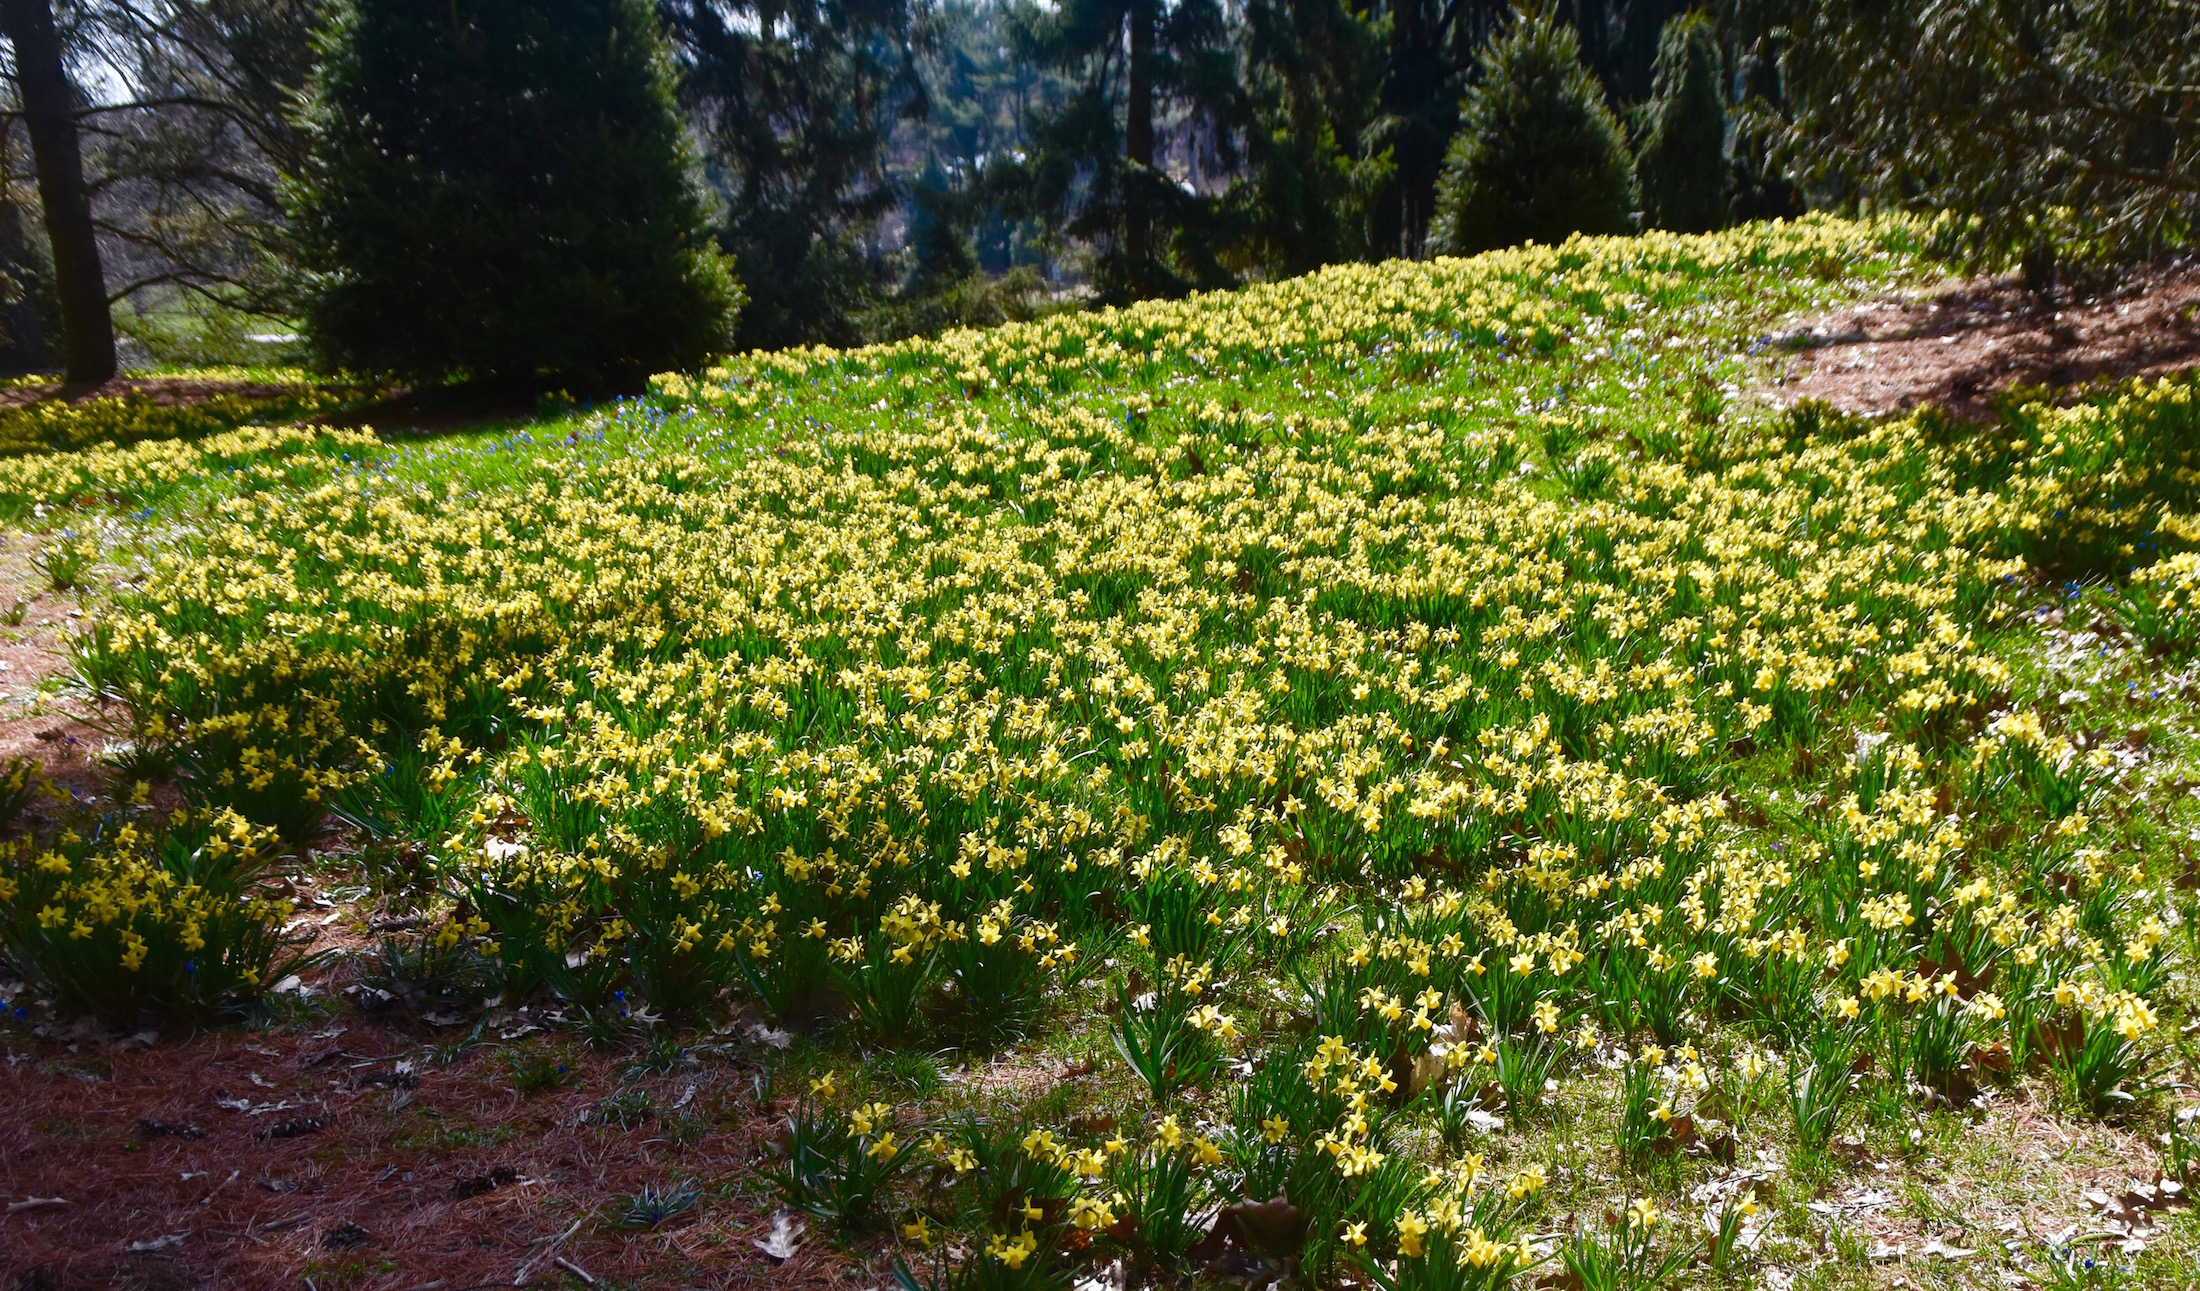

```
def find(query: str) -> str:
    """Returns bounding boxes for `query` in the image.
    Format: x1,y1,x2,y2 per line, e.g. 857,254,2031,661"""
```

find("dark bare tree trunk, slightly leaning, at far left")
0,0,114,385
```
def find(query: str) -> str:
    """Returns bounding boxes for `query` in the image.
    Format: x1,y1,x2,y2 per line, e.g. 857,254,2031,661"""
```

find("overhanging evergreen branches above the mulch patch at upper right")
1738,0,2200,277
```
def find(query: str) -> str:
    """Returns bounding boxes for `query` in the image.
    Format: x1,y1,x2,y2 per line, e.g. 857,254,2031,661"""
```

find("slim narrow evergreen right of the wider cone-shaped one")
1635,13,1729,233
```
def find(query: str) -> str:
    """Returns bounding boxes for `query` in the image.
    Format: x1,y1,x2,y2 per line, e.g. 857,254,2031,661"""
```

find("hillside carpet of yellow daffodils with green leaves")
0,220,2200,1291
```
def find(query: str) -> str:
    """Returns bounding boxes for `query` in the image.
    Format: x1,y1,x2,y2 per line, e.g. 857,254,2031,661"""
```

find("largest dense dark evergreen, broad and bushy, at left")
297,0,737,389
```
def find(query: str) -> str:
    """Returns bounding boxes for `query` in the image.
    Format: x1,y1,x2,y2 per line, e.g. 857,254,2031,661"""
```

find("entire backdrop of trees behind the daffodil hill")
0,0,2200,373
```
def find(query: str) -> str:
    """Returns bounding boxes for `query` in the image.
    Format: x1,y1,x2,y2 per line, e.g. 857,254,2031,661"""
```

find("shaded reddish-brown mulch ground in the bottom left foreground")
0,1009,884,1291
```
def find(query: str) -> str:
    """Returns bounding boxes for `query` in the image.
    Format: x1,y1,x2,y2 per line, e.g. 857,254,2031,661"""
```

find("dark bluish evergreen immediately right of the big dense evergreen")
658,0,928,350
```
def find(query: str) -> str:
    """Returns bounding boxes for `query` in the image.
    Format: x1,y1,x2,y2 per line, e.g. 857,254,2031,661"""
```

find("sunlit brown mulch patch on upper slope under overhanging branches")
1773,266,2200,418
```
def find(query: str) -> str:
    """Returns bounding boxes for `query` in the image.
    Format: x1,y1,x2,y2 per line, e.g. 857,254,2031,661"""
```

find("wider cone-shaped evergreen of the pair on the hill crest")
1432,13,1635,255
